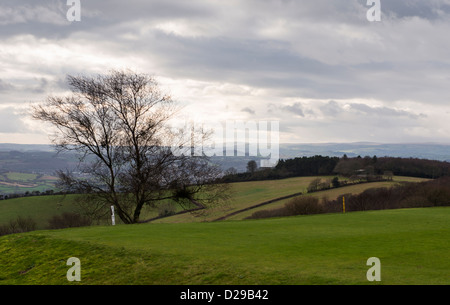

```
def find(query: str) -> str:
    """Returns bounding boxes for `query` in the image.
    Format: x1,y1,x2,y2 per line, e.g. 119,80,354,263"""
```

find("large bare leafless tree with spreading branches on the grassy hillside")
33,71,225,224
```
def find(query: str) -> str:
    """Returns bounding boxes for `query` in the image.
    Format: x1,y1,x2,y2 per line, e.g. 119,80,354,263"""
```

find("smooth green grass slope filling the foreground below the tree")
0,208,450,285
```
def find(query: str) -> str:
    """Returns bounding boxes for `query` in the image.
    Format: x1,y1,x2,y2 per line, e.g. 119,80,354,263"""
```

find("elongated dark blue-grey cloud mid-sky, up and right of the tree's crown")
147,32,355,92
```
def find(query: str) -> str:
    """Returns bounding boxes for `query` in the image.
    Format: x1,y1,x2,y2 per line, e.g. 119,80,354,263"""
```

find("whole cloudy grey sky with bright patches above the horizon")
0,0,450,144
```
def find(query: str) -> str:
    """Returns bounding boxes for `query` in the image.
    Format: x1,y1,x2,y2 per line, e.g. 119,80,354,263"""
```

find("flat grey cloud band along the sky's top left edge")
0,0,214,39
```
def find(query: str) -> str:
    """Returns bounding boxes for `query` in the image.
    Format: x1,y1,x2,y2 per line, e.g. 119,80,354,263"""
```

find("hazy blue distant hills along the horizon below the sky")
0,142,450,174
